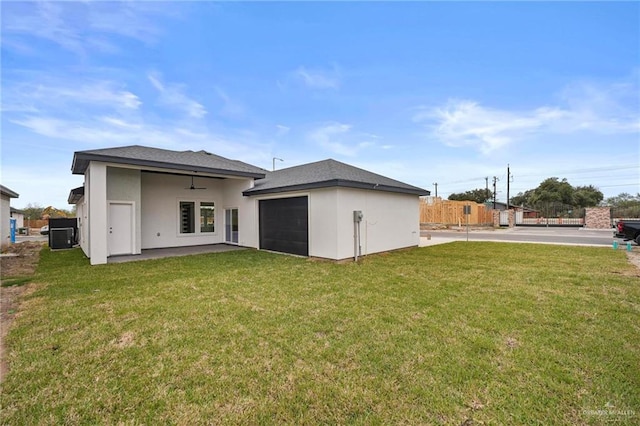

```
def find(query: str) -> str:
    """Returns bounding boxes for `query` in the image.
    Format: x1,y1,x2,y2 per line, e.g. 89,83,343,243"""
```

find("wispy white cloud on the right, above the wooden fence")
413,78,640,154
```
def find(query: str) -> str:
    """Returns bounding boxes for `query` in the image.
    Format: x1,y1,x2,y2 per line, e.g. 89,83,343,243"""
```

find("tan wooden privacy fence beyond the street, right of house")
420,197,493,225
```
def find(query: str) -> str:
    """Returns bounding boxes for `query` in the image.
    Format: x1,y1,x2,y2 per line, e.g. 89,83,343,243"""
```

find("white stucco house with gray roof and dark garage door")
69,146,429,265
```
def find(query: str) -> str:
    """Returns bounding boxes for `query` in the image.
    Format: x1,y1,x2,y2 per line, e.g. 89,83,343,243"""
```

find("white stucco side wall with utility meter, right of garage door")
336,188,420,259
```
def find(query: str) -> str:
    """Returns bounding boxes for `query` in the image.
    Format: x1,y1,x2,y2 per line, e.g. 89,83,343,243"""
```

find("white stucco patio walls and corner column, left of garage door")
82,162,257,265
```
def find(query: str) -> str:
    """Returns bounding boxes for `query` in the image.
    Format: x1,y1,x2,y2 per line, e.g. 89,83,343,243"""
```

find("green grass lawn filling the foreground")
0,242,640,425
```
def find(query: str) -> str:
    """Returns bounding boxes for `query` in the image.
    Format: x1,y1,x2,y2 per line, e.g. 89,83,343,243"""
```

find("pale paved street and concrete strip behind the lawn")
421,227,620,246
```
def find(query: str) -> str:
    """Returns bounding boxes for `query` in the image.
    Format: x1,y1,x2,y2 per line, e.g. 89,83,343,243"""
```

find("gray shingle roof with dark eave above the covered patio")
71,145,266,178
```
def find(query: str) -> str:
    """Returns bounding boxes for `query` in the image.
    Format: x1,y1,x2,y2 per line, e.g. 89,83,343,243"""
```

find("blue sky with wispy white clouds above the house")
1,1,640,208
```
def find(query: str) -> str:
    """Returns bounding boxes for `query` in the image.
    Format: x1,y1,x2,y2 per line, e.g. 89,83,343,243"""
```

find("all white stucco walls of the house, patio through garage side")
80,158,420,264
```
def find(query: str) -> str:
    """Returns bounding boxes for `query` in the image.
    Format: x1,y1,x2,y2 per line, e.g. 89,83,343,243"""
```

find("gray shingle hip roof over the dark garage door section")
243,159,430,195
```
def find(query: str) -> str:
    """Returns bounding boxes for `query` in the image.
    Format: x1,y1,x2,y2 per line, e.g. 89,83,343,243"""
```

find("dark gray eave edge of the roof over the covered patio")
71,152,265,179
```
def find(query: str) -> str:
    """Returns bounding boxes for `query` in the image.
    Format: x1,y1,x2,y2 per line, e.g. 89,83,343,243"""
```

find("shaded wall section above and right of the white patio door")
107,167,142,254
